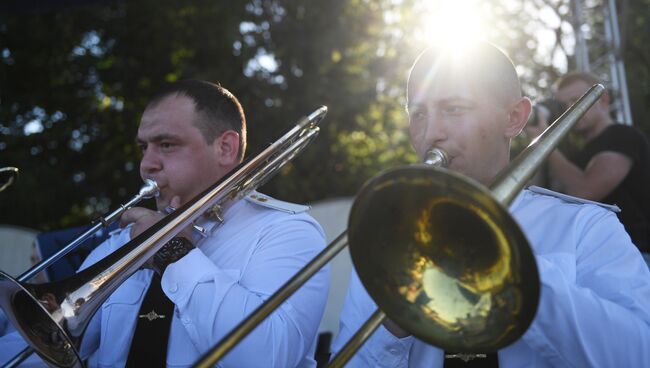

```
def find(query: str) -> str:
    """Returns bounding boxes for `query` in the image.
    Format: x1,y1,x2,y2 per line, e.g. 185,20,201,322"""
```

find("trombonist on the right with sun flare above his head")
333,43,650,367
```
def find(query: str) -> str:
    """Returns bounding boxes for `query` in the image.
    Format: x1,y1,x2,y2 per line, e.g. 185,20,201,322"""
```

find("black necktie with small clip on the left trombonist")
126,273,174,367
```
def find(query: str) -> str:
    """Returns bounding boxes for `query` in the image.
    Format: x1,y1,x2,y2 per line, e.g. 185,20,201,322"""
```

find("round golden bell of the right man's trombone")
348,164,539,353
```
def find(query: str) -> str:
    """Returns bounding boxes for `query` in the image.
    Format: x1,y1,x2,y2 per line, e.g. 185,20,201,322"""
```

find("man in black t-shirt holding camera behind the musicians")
528,72,650,265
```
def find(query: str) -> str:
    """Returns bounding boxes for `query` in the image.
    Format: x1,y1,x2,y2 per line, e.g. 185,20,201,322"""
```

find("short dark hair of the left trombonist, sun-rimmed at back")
147,79,246,160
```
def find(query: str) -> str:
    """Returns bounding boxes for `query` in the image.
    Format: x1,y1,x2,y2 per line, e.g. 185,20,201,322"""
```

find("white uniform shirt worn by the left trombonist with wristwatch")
0,194,329,368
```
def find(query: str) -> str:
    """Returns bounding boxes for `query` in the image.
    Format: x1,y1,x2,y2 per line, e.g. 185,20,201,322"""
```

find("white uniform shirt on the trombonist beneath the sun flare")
333,190,650,368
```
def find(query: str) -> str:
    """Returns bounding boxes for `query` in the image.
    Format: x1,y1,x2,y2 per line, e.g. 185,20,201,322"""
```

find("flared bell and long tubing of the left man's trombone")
0,106,327,367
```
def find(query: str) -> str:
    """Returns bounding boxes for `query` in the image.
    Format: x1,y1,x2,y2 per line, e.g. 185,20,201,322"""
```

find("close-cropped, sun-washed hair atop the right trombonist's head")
407,42,521,107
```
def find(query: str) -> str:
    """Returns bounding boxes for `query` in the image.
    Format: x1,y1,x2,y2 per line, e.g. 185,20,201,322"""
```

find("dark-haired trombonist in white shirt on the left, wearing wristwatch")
0,80,329,367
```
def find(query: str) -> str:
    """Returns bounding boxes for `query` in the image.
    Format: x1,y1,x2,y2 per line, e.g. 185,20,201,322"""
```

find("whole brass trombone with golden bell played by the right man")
195,84,605,368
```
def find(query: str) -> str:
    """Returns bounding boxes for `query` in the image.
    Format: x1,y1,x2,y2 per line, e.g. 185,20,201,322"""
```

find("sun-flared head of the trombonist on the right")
407,42,531,185
